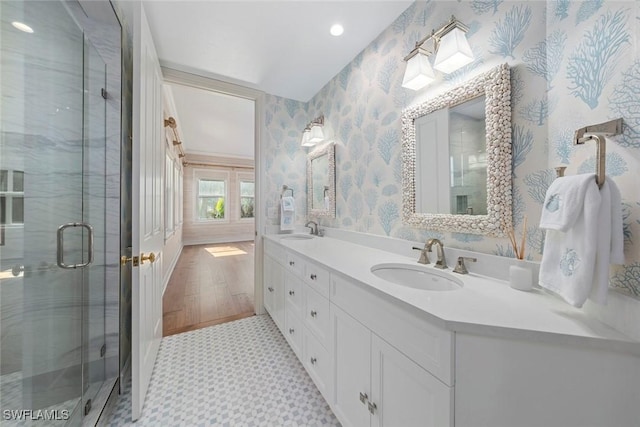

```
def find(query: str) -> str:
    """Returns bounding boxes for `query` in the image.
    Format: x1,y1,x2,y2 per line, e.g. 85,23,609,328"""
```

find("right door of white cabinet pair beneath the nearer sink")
371,334,453,427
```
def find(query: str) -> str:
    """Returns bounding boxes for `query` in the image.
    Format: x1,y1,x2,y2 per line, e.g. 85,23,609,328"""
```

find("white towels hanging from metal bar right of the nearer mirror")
539,174,624,307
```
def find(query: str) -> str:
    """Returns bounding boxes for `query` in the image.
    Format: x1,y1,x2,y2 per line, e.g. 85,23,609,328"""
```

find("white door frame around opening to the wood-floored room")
160,64,265,314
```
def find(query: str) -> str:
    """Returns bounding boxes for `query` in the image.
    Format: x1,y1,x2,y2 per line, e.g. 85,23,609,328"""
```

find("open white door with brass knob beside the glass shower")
131,2,164,420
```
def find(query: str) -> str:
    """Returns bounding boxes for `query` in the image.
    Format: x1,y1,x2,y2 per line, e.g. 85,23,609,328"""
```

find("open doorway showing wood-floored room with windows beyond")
163,68,263,335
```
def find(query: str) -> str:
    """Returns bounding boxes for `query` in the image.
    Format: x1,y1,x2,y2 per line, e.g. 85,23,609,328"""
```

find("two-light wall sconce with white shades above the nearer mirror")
402,15,473,90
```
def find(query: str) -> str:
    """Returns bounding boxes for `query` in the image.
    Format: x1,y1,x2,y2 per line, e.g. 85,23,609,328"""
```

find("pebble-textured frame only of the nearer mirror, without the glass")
402,64,512,236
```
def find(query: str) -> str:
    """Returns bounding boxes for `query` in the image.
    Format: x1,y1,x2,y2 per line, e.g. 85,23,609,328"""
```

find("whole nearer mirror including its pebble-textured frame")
402,64,512,236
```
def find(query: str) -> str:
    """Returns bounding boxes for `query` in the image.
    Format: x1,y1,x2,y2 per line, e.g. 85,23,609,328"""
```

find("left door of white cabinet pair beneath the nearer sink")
330,304,372,426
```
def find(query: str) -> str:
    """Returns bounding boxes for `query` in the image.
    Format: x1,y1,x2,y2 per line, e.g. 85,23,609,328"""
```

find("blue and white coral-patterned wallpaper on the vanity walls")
263,0,640,297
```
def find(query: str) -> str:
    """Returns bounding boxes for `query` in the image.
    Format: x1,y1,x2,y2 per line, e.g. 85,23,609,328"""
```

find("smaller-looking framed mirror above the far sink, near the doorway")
307,142,336,218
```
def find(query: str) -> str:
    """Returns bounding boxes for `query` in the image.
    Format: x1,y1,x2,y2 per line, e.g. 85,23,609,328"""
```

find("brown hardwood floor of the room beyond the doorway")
162,242,255,337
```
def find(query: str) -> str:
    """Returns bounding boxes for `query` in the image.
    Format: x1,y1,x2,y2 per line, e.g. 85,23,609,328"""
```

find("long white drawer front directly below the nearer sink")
331,274,454,386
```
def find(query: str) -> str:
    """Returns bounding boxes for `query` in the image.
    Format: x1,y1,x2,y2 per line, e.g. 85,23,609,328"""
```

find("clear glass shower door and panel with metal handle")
0,1,106,425
